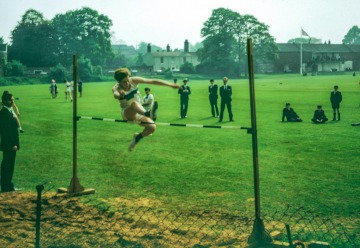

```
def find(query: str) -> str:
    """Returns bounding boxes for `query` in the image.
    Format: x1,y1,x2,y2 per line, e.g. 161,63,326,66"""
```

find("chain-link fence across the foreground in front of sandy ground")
0,186,360,248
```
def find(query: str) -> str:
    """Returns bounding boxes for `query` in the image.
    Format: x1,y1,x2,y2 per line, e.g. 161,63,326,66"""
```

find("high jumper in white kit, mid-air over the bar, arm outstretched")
112,68,180,152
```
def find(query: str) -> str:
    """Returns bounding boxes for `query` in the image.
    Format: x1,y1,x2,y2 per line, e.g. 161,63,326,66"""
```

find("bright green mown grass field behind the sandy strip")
1,74,360,217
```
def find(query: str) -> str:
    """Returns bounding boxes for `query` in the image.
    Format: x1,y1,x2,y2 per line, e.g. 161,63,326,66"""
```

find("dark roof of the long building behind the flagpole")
277,43,360,53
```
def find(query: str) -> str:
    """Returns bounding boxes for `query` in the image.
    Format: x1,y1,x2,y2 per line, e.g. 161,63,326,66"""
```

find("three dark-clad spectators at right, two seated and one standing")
282,85,342,124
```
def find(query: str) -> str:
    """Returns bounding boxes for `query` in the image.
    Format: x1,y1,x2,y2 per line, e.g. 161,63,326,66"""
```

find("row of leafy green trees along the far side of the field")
0,7,360,78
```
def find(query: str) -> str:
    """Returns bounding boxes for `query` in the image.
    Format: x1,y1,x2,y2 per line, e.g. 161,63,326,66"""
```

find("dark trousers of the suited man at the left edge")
1,151,16,192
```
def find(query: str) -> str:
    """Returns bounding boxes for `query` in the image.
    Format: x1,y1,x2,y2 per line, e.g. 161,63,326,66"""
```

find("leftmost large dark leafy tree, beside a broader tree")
9,9,56,66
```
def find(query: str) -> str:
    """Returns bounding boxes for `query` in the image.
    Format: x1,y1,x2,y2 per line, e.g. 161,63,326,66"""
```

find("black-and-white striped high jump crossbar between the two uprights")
76,116,249,130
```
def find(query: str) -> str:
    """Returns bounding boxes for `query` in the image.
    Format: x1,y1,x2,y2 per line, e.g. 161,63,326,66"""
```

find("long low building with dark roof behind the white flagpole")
274,43,360,73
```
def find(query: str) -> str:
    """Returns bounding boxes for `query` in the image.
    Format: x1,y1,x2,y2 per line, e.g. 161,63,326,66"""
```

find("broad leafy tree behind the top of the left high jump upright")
52,7,113,65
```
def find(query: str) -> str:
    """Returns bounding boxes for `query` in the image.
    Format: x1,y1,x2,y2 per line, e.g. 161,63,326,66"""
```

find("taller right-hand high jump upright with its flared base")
247,38,272,247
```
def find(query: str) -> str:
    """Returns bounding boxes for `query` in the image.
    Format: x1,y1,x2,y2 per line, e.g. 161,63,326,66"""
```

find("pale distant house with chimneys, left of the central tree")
143,40,200,72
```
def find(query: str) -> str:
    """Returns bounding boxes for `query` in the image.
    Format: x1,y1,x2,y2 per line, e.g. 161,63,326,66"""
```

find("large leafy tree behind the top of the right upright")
198,8,277,75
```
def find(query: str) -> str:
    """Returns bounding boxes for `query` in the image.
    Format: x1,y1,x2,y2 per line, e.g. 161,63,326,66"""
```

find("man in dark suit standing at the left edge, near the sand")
0,92,20,192
